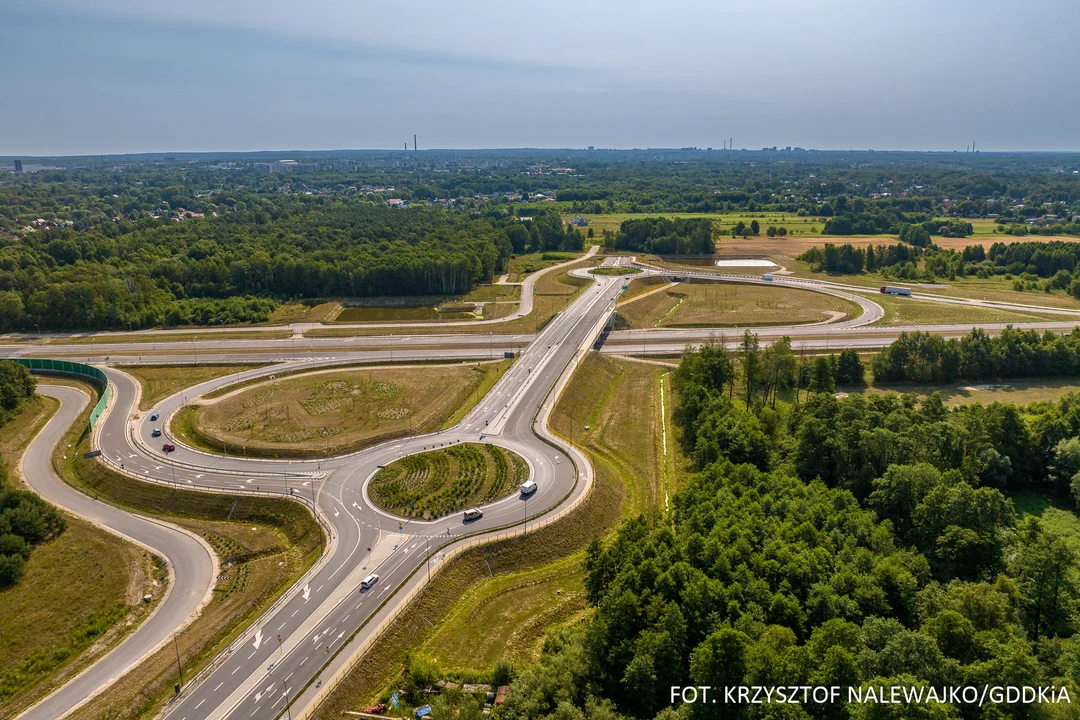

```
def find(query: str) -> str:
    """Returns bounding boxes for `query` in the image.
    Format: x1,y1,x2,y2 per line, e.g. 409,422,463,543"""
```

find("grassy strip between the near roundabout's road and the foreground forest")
304,353,683,720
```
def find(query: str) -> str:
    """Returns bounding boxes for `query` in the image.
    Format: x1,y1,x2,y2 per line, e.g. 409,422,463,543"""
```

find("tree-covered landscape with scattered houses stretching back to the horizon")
0,153,1080,331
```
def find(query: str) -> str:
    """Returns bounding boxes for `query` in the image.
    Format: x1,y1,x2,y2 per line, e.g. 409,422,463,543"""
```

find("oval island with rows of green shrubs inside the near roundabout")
369,443,529,520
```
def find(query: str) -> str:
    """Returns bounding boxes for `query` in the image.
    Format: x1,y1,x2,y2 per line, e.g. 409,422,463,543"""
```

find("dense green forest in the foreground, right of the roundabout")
500,338,1080,720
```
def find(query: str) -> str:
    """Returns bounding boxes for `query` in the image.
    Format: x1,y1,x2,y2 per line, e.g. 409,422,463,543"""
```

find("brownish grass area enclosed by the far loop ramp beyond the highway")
618,281,860,328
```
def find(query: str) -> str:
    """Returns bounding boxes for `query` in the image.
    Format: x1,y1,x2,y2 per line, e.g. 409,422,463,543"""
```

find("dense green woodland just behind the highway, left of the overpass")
0,203,584,330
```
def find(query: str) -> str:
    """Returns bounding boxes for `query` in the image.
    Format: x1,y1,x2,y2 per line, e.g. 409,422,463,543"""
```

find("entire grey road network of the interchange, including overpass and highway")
12,258,1080,720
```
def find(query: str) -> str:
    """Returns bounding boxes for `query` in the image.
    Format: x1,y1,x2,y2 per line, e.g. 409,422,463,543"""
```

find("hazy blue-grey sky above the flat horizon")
0,0,1080,155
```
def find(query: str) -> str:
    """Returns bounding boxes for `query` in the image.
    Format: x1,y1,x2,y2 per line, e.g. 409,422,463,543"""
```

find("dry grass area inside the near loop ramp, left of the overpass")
182,361,509,457
